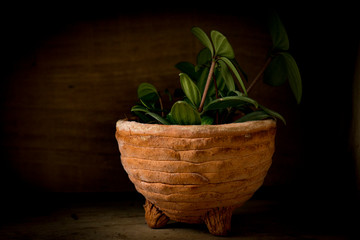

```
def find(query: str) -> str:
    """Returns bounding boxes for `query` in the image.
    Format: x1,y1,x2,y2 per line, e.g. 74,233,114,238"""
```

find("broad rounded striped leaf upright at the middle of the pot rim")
170,101,201,125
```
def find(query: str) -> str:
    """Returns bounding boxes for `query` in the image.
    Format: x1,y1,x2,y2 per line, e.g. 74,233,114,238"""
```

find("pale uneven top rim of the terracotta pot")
116,119,276,137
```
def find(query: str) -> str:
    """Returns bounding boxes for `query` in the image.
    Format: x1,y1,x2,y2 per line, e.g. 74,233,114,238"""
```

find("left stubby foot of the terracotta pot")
144,200,169,228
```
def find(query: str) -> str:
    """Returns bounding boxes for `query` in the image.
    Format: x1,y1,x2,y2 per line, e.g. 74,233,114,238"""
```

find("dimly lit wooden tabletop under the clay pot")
0,194,359,240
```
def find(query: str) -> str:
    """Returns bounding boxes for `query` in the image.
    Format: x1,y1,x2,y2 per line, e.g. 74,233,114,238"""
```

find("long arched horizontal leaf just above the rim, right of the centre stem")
203,96,258,112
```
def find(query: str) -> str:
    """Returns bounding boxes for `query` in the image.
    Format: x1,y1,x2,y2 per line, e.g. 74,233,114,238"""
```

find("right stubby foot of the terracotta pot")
204,207,234,236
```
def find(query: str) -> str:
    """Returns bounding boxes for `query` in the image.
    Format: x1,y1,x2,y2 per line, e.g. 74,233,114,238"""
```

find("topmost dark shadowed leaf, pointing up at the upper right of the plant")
268,12,289,51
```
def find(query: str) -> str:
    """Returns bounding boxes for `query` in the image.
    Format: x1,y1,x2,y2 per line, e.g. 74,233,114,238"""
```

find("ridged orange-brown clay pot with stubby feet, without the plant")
116,120,276,235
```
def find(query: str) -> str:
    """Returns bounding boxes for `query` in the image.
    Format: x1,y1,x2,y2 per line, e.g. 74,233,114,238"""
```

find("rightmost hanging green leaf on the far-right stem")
281,52,302,104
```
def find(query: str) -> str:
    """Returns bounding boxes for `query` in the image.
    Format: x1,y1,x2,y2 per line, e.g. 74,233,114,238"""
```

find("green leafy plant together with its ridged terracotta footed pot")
116,14,302,235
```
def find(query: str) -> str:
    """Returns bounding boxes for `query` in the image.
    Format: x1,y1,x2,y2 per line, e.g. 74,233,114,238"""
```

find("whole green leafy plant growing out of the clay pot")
131,14,302,125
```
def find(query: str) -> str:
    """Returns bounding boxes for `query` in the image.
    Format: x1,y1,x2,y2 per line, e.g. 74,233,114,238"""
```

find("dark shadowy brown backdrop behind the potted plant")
0,3,360,234
